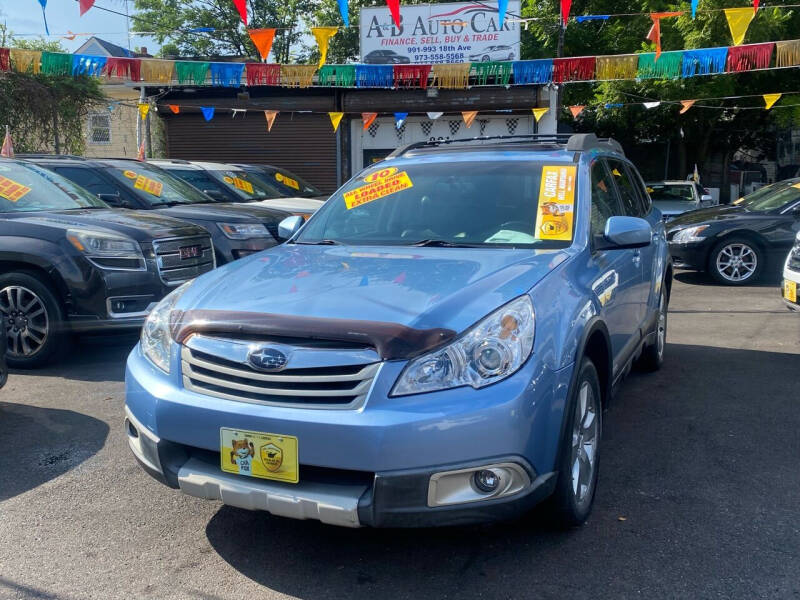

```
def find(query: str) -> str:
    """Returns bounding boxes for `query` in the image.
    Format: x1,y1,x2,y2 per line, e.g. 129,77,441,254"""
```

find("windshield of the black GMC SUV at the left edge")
0,161,108,213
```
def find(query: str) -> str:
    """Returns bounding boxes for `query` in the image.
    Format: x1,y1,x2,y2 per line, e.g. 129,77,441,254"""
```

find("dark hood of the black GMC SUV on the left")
6,209,206,242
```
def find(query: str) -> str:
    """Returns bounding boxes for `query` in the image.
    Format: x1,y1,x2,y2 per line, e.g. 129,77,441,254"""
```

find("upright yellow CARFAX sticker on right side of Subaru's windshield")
536,165,576,241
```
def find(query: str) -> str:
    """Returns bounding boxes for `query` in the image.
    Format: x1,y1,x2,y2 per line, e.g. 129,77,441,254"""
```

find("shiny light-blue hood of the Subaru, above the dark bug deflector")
178,244,567,332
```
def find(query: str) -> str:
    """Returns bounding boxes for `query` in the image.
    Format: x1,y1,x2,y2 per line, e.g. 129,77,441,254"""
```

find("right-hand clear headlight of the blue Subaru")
391,294,535,396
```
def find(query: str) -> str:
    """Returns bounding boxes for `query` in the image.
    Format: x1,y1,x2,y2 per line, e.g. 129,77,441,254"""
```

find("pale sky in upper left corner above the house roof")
0,0,158,54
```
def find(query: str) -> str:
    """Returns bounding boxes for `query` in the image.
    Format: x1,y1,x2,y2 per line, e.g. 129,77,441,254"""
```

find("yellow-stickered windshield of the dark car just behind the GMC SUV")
105,160,213,206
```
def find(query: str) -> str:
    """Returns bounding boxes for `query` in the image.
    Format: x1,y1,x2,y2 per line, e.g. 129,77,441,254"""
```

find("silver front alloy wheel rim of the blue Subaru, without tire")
570,381,600,507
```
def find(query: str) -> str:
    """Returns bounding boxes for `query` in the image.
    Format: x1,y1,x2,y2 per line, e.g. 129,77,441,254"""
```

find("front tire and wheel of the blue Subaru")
549,358,603,528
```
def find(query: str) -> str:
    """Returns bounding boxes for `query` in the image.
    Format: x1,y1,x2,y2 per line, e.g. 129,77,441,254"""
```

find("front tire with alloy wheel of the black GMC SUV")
0,271,66,369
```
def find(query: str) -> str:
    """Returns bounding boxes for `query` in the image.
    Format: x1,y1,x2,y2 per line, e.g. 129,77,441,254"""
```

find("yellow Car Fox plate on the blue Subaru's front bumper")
219,427,300,483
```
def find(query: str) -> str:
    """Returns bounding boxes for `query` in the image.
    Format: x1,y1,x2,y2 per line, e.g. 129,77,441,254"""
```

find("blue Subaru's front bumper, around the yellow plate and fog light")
126,347,572,527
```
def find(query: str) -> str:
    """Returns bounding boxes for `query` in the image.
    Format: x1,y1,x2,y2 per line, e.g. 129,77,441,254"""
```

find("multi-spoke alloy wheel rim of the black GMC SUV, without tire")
0,285,50,358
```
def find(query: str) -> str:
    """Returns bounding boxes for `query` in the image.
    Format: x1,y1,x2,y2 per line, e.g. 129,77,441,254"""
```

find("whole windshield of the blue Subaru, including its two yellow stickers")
295,161,576,248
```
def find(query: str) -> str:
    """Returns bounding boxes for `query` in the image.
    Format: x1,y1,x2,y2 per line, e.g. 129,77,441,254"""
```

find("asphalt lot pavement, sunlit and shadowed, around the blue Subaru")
0,272,800,600
